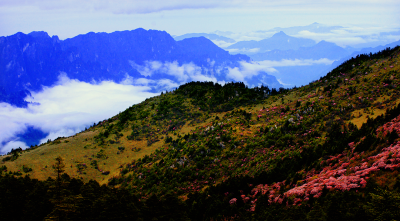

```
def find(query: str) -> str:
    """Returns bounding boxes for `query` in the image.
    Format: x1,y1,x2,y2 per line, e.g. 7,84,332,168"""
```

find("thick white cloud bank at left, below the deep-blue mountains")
0,75,158,153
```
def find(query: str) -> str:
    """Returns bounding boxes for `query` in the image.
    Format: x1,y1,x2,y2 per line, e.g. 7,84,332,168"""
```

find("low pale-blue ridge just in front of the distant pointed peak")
250,41,349,61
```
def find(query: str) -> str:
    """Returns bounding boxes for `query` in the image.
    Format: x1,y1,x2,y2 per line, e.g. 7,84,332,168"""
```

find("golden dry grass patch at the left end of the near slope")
2,126,169,184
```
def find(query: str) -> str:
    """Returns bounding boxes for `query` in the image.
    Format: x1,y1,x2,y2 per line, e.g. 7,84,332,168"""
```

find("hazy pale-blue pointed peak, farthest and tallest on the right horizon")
226,31,315,54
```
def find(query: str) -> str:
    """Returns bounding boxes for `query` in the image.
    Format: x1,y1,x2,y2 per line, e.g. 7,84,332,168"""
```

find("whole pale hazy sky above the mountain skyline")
0,0,400,39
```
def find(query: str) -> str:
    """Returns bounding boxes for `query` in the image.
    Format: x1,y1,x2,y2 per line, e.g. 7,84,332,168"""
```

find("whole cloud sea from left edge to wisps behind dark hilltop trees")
0,61,284,154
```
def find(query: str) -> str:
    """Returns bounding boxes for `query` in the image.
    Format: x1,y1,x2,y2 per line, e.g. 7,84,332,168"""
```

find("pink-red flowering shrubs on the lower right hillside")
241,116,400,211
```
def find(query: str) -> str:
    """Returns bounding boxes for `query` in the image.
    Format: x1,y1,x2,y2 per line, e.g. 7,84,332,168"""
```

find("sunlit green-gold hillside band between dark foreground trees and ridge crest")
0,45,400,198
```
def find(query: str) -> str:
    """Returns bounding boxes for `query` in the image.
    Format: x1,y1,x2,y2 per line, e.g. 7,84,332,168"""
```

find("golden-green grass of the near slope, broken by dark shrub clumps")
0,45,400,205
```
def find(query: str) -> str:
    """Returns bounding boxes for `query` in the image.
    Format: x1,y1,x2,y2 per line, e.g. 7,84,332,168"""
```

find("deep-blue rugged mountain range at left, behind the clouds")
0,28,279,106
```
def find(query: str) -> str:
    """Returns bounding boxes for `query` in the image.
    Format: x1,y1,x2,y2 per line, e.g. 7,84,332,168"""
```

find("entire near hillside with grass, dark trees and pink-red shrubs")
0,47,400,220
